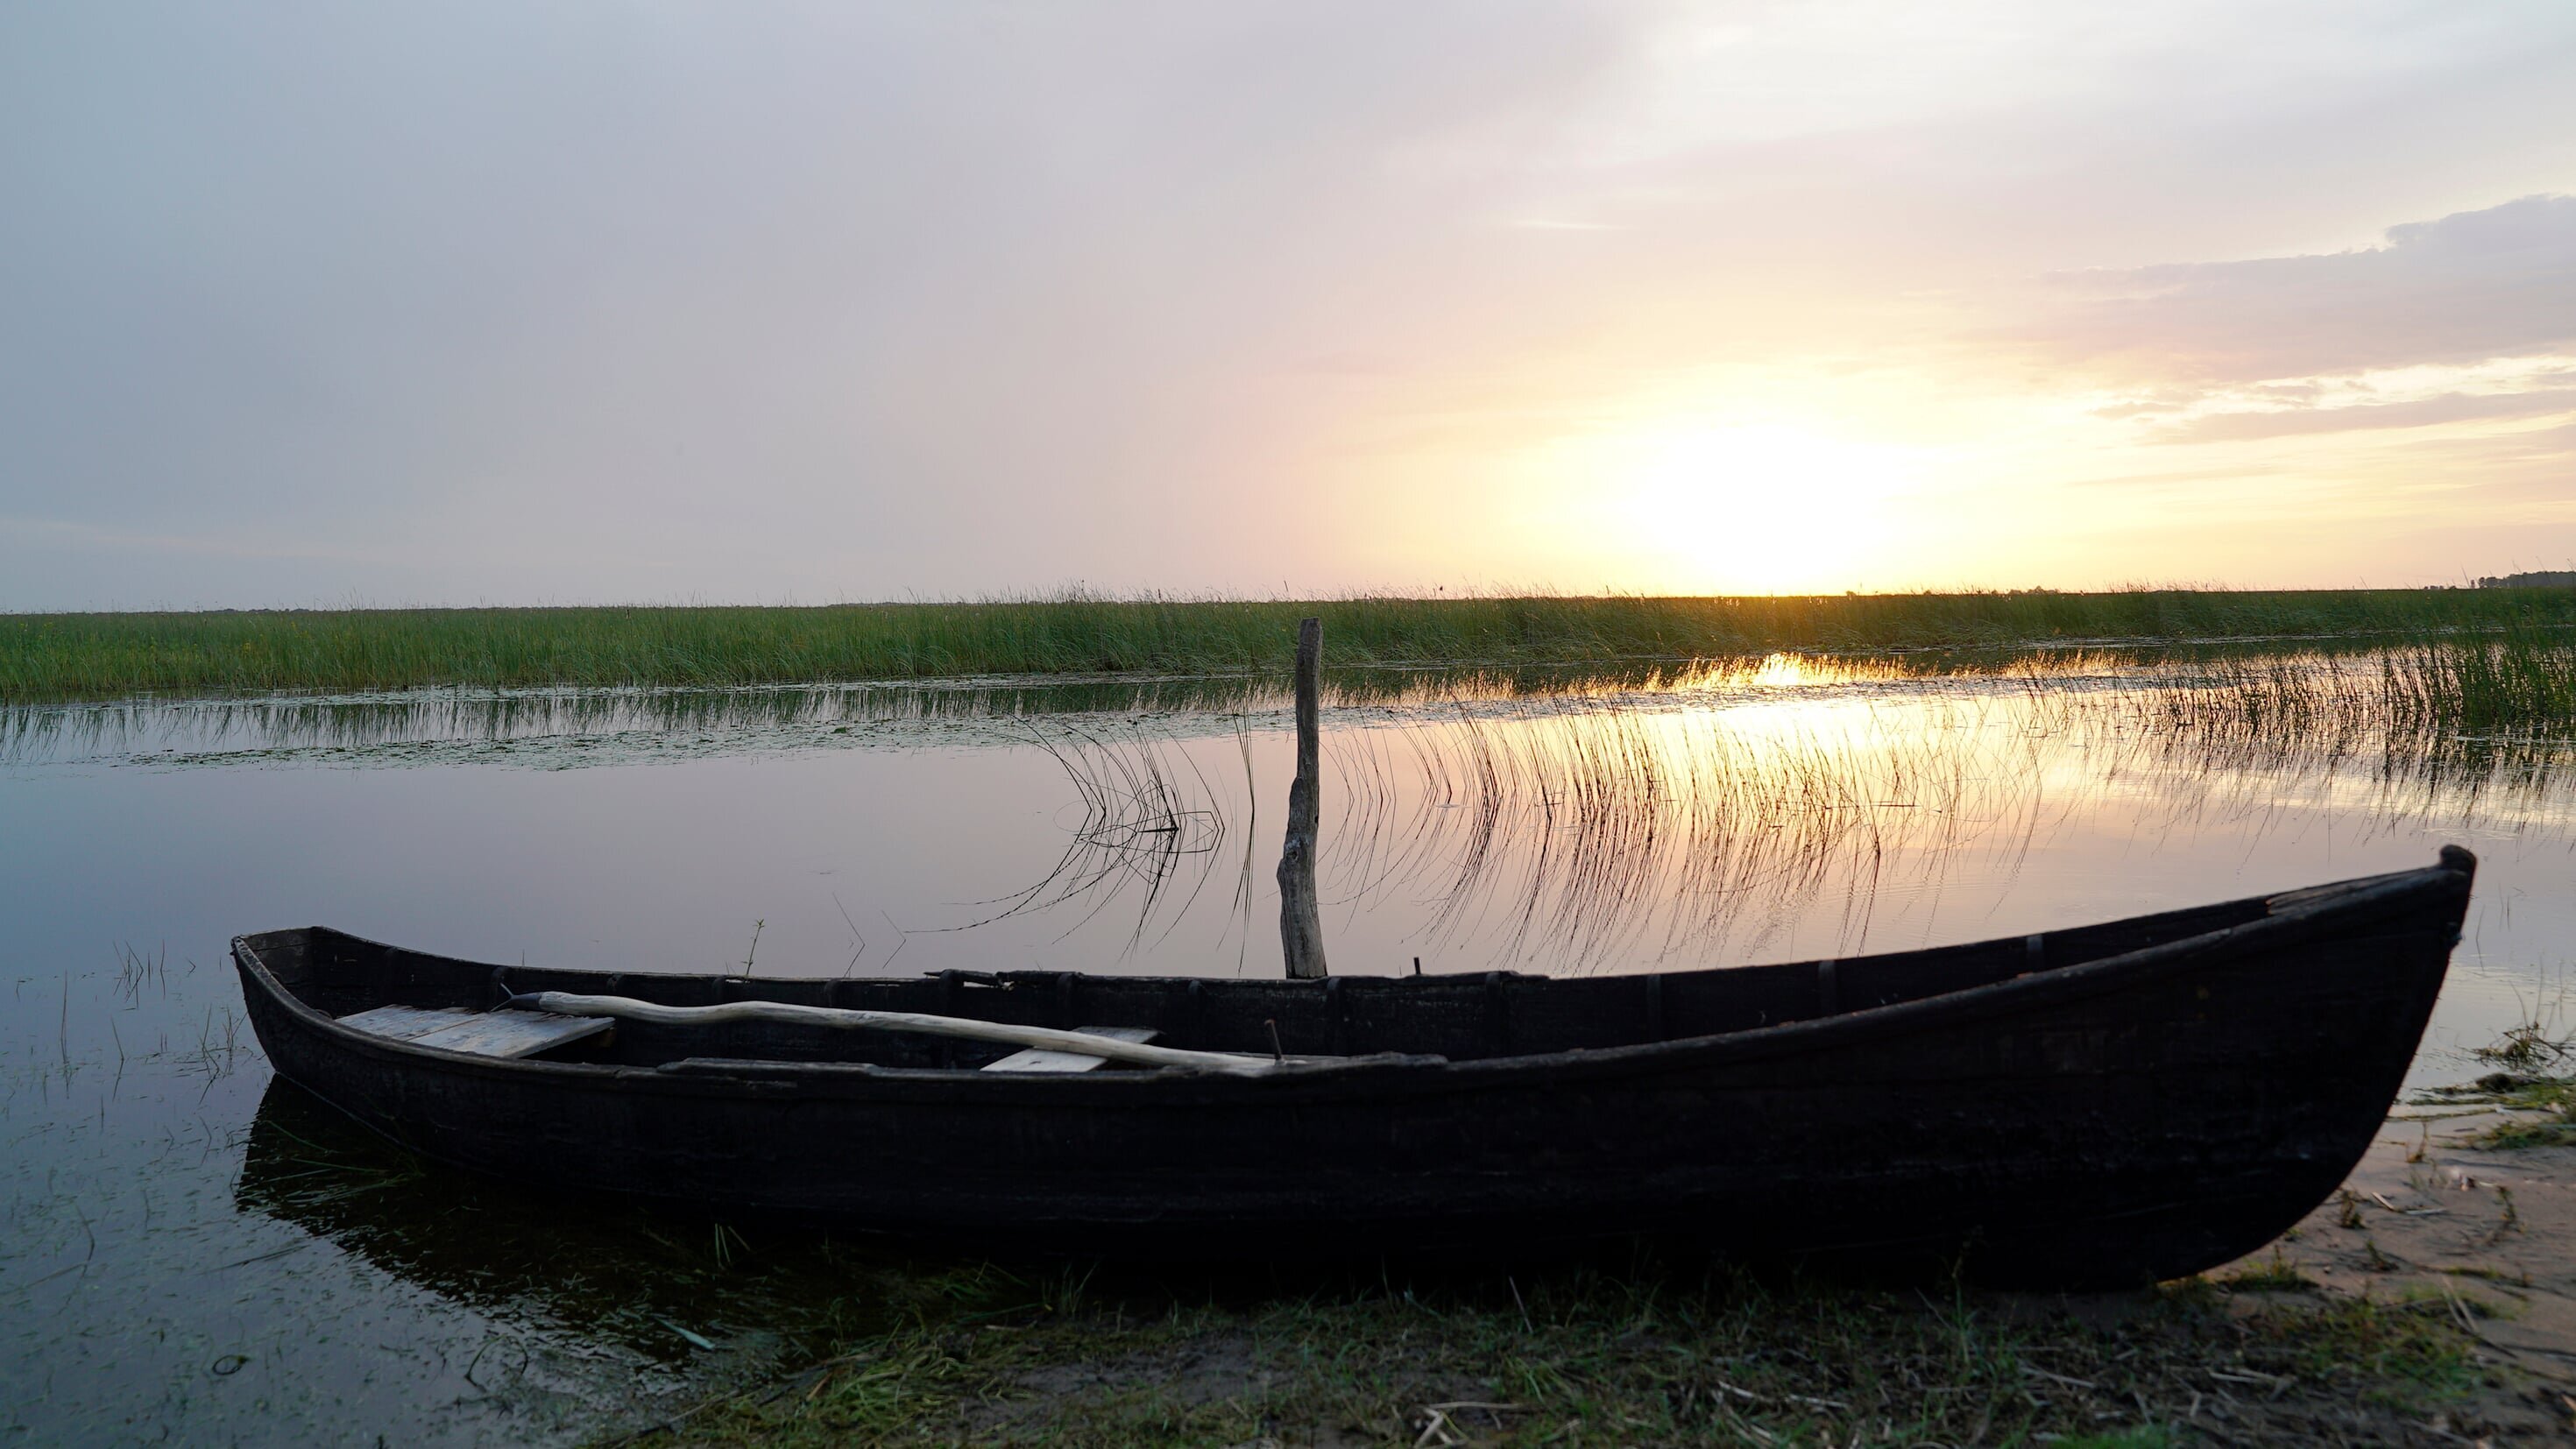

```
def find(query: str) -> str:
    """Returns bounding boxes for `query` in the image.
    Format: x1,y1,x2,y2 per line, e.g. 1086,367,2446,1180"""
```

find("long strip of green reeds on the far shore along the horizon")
0,590,2576,705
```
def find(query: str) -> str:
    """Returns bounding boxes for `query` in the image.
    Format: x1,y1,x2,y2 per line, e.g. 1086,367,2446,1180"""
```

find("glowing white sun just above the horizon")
1584,425,1914,592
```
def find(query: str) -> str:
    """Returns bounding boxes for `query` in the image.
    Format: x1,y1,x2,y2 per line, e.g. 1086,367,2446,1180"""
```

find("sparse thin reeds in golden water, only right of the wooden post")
1329,703,2035,971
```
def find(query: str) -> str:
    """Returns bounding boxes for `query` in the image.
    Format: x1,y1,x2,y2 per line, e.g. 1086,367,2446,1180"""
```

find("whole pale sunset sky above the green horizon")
0,0,2576,610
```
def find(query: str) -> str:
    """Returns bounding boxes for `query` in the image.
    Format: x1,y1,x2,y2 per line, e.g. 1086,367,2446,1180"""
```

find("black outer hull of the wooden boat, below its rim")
235,852,2468,1290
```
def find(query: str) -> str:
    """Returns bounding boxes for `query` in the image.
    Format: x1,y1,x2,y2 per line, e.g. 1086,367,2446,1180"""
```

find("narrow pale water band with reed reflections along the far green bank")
0,646,2462,767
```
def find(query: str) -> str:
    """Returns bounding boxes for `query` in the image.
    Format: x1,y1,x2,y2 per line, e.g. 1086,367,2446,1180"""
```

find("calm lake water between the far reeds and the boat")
0,654,2576,1444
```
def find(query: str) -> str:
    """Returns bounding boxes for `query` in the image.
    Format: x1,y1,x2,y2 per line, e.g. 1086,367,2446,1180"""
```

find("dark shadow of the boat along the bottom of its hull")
235,1076,2151,1364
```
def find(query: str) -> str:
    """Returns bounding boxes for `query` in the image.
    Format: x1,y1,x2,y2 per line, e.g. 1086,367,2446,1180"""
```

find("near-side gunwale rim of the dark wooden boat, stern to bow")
232,847,2475,1101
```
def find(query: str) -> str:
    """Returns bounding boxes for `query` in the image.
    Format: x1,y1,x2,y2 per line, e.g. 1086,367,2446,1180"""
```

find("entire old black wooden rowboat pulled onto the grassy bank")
235,847,2475,1290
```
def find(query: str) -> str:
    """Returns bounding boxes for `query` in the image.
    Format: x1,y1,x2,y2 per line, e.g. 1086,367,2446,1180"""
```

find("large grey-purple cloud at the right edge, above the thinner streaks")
2030,195,2576,389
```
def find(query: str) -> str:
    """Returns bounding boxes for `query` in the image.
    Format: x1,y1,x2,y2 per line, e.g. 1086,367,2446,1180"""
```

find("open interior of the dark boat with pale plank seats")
239,883,2365,1071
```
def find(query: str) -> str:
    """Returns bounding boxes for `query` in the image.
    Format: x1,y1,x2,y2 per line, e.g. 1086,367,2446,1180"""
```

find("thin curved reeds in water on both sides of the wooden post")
948,680,2070,971
